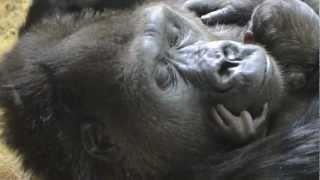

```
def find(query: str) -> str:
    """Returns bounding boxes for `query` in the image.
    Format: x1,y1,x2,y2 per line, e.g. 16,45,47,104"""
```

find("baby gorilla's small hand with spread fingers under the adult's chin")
210,103,268,144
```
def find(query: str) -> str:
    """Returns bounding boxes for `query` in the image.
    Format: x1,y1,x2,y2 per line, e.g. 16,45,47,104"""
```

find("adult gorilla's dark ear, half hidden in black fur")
81,123,119,162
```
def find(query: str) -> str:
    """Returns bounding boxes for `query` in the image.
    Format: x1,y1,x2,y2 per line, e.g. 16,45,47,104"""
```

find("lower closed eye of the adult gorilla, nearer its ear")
154,64,176,90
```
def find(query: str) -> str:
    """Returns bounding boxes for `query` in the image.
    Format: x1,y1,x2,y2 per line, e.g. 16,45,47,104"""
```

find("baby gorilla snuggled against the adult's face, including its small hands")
185,0,319,142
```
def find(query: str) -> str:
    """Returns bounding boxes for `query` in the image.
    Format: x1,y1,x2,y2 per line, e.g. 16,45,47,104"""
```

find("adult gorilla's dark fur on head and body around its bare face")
0,0,319,180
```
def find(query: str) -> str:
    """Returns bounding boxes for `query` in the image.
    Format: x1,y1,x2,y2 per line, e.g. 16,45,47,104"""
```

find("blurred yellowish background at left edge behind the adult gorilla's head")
0,0,35,180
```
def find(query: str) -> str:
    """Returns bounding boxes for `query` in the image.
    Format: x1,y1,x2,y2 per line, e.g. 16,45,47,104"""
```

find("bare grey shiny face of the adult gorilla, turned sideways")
133,5,283,118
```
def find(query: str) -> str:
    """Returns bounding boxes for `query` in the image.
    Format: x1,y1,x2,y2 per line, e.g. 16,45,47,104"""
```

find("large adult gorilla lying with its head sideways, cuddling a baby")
0,1,318,180
